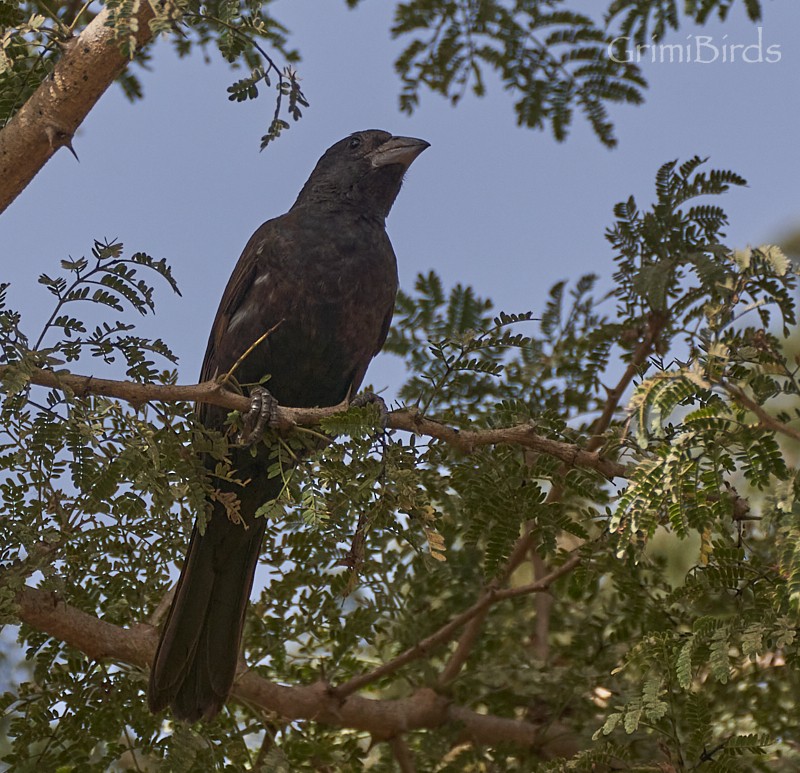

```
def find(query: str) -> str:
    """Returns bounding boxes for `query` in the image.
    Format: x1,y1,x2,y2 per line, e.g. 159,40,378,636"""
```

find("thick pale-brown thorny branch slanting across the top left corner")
0,2,154,212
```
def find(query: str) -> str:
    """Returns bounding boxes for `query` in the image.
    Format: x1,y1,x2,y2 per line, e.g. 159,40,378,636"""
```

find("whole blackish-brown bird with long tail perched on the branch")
148,129,429,722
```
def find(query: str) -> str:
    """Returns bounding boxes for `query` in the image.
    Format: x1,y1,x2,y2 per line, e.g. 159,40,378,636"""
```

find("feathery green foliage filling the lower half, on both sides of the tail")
0,137,800,771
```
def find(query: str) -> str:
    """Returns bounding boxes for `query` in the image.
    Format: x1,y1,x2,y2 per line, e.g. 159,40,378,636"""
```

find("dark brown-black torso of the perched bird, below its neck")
199,208,397,416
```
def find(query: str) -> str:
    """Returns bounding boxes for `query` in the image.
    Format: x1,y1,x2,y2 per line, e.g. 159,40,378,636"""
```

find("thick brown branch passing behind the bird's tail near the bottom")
16,586,564,747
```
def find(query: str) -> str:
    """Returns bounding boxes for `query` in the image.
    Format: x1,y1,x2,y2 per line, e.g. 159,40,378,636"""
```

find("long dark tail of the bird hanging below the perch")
148,473,281,722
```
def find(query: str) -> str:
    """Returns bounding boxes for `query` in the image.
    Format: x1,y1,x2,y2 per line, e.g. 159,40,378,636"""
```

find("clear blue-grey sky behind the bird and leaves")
0,0,800,399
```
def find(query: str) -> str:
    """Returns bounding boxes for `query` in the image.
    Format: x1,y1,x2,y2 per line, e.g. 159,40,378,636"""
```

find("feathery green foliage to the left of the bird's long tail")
0,242,222,770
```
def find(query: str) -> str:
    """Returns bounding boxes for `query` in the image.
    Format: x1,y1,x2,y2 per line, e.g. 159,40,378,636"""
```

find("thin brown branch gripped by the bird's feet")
0,365,626,478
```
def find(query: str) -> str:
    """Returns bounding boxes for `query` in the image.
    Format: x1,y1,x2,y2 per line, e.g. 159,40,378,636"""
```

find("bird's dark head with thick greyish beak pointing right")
293,129,429,218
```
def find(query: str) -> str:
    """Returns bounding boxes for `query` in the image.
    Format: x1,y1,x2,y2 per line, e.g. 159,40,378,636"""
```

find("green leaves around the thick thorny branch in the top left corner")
0,0,308,149
